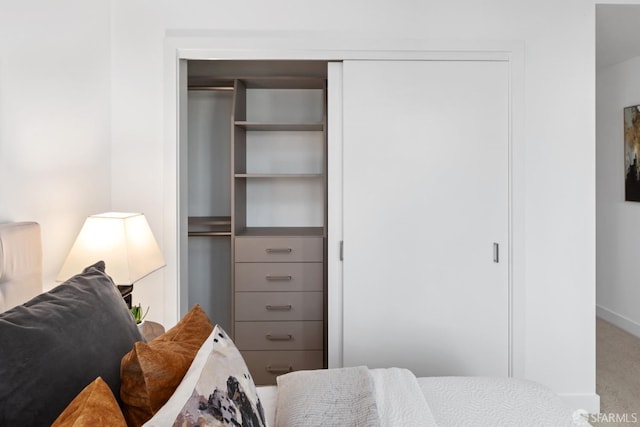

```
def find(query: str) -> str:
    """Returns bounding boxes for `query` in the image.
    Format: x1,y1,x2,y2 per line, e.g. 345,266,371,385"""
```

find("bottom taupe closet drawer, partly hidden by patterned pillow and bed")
242,350,324,385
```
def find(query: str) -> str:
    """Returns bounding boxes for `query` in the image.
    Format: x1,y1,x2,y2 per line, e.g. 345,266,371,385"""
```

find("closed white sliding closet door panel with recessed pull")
343,61,509,376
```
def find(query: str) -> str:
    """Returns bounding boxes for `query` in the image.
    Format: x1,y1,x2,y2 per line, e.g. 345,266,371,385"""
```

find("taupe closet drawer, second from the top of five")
235,262,324,292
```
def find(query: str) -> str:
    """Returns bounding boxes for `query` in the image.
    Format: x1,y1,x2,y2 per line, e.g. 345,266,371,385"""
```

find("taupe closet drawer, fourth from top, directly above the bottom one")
233,321,324,350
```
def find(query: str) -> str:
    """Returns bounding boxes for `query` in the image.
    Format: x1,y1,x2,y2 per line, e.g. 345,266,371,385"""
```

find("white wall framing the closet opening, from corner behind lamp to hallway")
111,0,598,410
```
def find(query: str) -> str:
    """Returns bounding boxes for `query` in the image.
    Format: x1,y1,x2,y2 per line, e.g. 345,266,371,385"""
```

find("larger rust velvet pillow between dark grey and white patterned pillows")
120,304,213,426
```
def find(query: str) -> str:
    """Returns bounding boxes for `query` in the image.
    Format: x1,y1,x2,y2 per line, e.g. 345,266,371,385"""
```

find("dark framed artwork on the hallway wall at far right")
624,105,640,202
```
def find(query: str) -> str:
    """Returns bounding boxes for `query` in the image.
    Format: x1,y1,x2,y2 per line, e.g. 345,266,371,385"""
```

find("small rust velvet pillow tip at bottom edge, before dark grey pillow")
51,377,127,427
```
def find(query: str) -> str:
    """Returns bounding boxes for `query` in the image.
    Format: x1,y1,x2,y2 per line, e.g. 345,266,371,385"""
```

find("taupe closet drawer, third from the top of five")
235,292,323,321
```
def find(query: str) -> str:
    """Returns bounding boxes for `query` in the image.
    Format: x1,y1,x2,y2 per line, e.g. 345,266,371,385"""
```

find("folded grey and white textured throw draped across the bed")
270,366,436,427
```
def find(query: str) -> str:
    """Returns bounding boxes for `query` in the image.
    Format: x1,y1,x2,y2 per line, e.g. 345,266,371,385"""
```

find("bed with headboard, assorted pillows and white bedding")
0,222,589,427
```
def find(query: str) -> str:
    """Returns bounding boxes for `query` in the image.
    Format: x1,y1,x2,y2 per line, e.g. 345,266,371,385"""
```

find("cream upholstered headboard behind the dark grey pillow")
0,222,42,312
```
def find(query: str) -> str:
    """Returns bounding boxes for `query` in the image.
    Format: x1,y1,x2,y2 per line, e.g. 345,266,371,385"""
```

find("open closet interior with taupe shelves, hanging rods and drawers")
187,61,327,384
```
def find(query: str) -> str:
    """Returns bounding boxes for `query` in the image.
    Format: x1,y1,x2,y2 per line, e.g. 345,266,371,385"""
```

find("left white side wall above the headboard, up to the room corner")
0,0,111,288
